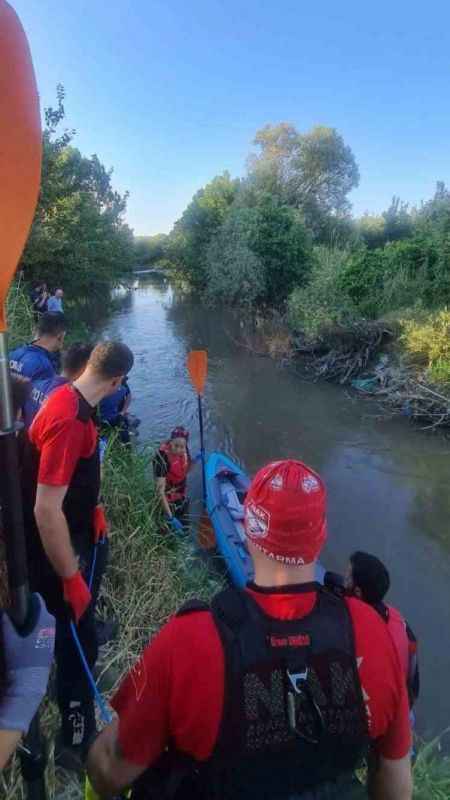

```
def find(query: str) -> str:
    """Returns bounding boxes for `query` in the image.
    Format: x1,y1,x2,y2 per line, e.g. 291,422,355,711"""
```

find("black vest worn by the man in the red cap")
133,584,369,800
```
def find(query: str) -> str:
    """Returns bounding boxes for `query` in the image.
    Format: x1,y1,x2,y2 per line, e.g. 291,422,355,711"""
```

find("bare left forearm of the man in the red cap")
87,720,146,798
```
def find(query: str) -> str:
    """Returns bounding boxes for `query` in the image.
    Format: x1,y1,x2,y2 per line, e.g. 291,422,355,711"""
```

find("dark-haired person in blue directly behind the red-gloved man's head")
23,342,92,428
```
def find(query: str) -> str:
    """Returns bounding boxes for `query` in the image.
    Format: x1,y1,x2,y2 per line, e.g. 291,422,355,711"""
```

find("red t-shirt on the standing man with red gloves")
28,384,97,486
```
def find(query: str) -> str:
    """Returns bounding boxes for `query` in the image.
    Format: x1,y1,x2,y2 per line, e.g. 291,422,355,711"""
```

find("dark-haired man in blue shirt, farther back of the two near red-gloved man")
9,313,67,381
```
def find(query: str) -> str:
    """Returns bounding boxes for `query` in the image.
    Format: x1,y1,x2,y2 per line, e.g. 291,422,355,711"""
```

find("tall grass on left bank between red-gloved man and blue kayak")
102,442,219,672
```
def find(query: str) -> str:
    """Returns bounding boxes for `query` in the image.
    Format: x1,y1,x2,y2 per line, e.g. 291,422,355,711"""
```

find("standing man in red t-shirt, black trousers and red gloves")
22,342,133,769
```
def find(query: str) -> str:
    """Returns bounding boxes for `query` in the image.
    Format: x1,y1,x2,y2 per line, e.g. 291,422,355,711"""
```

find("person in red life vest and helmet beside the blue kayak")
153,425,197,532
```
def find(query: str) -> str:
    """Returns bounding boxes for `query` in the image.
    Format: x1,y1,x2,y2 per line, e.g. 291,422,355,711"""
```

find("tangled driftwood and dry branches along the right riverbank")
232,310,450,431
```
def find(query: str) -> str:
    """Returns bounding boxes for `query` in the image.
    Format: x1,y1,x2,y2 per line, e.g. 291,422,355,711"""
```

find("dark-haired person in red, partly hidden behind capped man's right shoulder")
345,550,420,708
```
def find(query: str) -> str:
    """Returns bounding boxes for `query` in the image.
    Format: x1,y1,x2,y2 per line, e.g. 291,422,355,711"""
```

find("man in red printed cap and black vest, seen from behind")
88,461,412,800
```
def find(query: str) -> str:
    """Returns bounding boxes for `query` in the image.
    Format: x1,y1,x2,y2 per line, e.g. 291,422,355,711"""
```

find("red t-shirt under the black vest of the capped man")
112,585,411,767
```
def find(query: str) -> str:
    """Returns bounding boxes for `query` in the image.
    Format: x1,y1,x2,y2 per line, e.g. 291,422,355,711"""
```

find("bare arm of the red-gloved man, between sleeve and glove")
34,483,78,578
